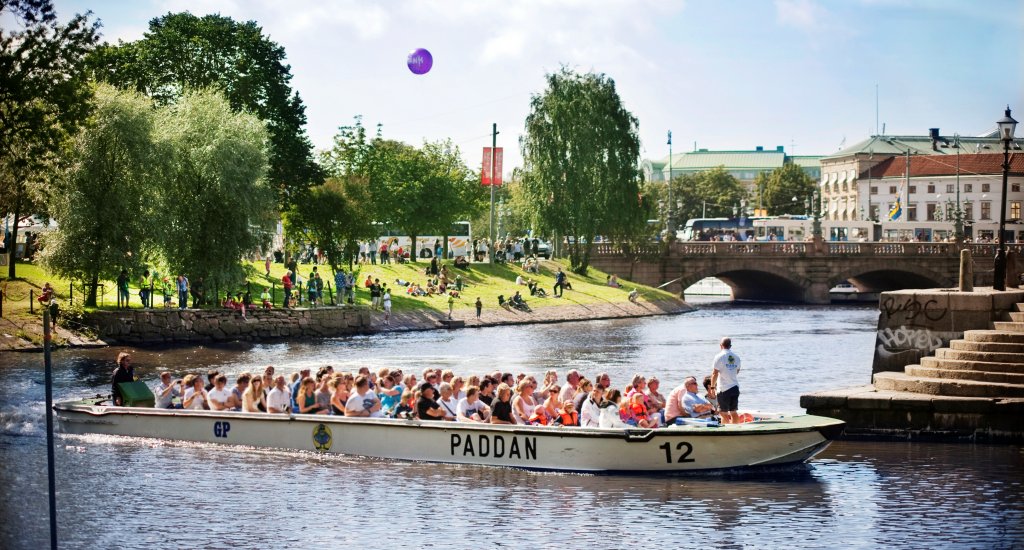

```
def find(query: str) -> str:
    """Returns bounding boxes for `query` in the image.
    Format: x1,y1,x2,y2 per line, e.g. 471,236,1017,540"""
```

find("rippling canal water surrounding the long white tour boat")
0,303,1024,549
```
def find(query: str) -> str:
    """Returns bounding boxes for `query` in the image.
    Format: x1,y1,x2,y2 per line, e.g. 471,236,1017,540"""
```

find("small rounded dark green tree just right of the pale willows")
285,176,377,271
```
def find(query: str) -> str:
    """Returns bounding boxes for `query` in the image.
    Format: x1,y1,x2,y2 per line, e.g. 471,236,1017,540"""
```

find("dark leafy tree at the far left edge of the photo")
0,0,98,279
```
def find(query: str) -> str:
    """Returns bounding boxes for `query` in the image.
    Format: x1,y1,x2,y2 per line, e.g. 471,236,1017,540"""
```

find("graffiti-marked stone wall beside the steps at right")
871,288,1024,374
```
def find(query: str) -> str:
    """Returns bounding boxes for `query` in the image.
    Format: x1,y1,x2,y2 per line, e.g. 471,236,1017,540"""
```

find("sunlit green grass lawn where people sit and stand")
0,254,675,319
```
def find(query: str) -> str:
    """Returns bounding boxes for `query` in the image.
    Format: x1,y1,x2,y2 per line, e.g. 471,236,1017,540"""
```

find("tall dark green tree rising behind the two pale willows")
89,13,324,211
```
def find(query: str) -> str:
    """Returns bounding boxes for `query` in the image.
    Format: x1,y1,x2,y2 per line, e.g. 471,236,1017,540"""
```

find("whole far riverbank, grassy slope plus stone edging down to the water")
0,256,692,351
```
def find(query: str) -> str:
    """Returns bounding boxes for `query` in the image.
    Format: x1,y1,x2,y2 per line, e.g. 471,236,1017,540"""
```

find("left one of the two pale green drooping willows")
41,85,161,306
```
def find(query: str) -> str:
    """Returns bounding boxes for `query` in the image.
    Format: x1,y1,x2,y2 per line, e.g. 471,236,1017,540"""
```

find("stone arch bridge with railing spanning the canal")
591,241,1024,304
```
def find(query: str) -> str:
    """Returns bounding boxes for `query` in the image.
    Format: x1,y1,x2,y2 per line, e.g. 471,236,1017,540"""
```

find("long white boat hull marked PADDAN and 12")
54,399,844,473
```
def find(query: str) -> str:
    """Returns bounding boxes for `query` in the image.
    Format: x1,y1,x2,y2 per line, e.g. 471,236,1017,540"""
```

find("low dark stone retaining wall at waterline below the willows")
86,307,371,344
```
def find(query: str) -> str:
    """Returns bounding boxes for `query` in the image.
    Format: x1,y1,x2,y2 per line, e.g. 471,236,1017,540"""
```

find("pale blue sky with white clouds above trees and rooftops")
54,0,1024,173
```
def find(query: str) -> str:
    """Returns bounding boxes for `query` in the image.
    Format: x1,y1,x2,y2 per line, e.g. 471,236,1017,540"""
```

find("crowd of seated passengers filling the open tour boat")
140,357,718,428
